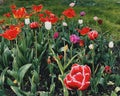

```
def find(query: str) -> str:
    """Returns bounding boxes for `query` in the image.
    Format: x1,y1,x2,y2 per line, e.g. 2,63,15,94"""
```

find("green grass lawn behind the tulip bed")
0,0,120,41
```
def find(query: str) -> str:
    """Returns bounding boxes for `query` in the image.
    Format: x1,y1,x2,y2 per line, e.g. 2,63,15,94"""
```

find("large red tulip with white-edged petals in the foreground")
64,64,91,91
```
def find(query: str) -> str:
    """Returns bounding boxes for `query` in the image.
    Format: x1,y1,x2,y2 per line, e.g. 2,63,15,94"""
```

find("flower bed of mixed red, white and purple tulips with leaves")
0,3,120,96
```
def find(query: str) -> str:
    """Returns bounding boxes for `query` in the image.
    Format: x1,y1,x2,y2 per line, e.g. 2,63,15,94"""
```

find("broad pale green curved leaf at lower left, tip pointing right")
18,64,32,83
